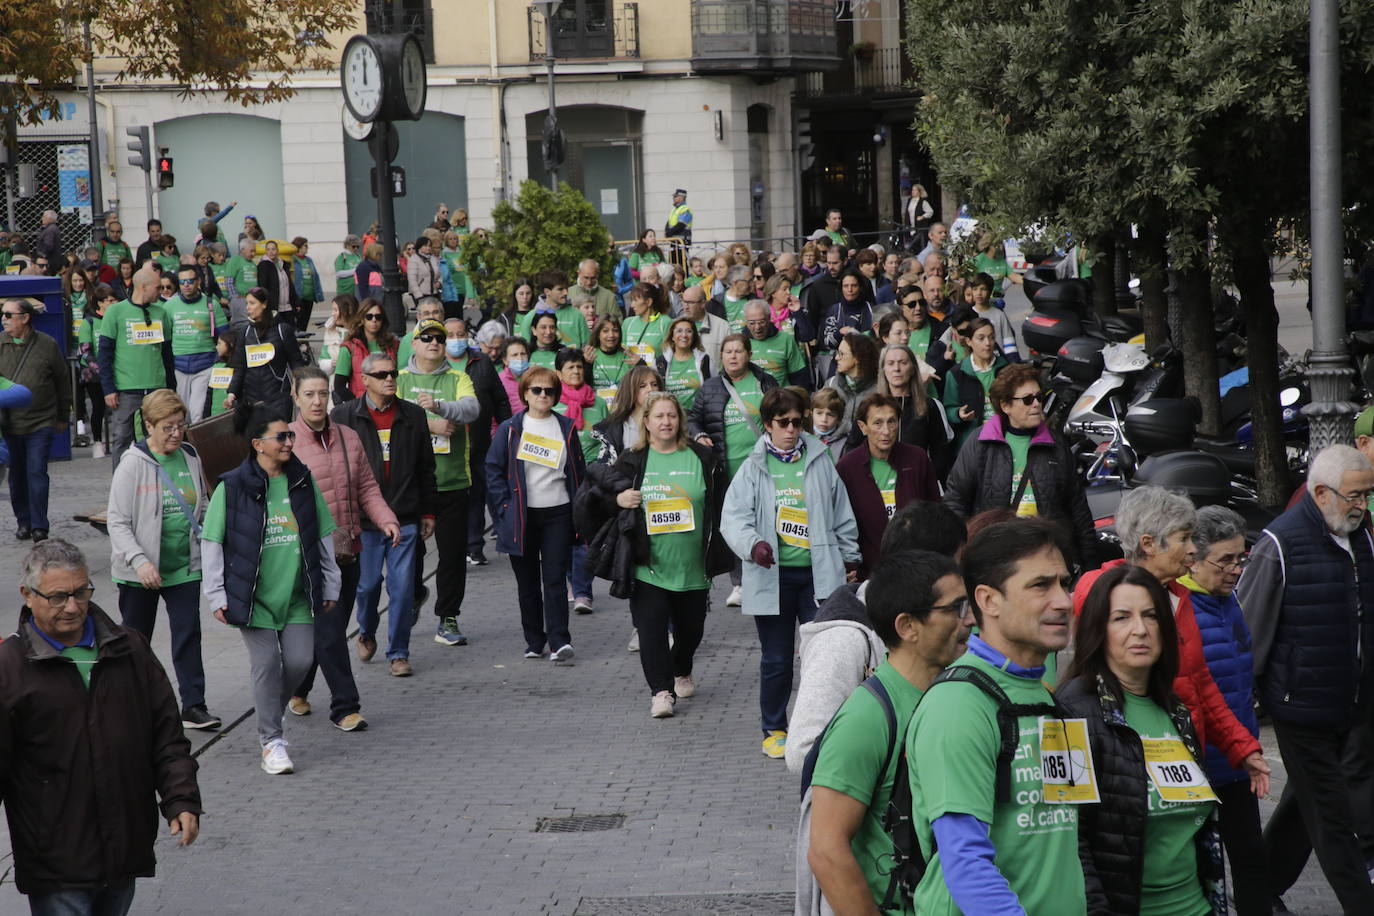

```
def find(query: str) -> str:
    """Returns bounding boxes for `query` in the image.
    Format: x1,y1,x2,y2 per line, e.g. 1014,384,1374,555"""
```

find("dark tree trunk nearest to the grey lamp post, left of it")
1228,235,1292,507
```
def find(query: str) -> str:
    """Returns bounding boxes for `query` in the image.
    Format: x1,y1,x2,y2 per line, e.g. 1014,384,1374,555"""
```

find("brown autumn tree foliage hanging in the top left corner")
0,0,361,141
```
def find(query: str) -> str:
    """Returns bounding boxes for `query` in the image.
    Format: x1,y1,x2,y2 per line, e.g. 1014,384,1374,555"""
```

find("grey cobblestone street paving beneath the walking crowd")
0,447,1337,916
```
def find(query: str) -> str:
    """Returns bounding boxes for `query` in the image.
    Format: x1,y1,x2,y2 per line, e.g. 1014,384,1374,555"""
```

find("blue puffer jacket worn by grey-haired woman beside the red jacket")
1179,575,1260,786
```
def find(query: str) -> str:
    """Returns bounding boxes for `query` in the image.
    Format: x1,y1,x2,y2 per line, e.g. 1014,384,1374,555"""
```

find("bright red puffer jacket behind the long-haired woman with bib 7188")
1073,560,1260,768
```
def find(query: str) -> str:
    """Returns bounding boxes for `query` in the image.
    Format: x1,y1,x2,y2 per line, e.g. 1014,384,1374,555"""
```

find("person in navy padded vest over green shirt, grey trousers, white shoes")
201,403,339,776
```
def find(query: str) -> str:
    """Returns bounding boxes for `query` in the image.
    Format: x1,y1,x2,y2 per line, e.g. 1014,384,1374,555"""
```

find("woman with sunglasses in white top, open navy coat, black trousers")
486,362,587,662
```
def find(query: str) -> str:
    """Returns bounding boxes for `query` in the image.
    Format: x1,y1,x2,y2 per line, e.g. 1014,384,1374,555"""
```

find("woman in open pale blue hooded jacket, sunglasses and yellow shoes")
720,387,861,758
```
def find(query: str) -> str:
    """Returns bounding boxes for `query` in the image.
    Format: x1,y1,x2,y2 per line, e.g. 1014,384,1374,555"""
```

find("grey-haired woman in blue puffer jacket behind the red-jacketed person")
1179,505,1264,916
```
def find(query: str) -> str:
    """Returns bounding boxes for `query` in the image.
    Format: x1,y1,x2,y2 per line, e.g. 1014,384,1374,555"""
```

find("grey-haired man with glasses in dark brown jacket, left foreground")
0,540,201,916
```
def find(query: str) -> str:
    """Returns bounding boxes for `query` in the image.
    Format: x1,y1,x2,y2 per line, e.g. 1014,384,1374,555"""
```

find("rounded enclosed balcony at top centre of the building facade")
691,0,840,76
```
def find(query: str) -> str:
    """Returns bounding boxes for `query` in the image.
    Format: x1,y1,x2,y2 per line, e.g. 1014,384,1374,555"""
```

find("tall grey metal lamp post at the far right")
1303,0,1359,455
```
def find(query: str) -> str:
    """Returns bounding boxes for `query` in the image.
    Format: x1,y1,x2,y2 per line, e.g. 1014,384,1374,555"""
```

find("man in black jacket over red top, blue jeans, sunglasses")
330,353,438,677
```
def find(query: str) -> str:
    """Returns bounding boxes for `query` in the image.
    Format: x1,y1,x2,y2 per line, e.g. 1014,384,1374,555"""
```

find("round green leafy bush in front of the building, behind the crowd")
463,180,614,308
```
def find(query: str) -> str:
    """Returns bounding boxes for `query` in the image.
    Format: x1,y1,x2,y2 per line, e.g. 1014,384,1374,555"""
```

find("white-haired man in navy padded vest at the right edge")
1235,445,1374,913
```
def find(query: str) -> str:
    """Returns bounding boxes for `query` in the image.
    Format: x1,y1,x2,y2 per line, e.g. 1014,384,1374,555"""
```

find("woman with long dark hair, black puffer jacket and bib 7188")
1041,566,1231,916
